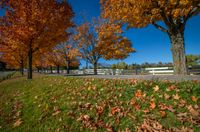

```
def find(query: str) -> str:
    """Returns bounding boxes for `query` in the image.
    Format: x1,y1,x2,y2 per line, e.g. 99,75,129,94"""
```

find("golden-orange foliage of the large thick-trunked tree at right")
101,0,200,27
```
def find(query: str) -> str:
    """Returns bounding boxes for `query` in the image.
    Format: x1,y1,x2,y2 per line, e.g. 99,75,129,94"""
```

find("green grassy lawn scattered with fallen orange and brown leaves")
0,75,200,131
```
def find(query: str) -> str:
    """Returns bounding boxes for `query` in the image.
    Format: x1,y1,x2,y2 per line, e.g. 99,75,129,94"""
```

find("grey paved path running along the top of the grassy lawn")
61,75,200,81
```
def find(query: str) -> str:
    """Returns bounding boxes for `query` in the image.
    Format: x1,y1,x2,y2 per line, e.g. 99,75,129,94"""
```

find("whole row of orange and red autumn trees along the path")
0,0,200,79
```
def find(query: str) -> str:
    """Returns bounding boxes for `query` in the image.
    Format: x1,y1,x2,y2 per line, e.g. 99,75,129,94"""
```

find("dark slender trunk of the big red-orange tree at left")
28,42,33,79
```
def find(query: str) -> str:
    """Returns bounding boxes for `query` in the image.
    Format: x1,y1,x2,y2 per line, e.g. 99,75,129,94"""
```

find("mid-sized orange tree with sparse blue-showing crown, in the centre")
75,19,134,75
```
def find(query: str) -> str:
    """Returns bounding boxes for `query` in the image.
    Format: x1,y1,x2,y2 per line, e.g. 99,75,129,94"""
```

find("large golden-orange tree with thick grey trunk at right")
101,0,200,74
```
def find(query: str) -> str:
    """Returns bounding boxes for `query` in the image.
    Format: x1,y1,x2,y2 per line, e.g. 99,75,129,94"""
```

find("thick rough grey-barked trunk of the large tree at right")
170,32,187,75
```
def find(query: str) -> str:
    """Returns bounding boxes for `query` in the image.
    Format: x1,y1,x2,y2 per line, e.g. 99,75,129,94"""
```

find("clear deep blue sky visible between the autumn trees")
0,0,200,67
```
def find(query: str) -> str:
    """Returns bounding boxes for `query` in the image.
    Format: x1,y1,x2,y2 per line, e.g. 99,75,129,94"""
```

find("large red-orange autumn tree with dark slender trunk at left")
0,0,73,79
